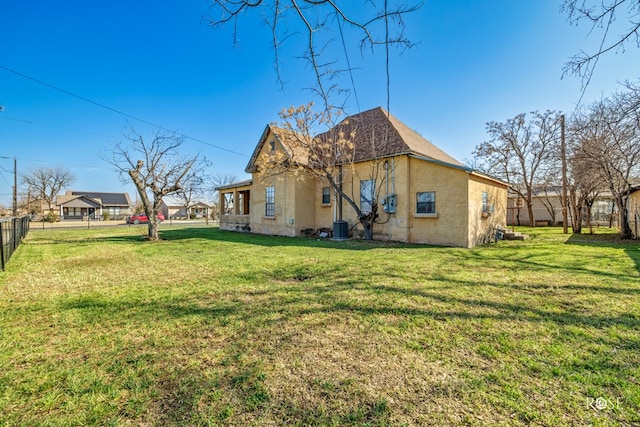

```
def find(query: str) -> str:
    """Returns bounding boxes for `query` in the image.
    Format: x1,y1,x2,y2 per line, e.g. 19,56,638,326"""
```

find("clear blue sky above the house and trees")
0,0,639,206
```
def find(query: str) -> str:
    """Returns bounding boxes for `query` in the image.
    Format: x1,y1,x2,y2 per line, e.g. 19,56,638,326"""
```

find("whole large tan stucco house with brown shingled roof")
218,108,507,247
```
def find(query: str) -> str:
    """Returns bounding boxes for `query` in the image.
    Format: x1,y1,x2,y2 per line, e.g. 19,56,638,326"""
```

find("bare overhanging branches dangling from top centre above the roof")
209,0,421,109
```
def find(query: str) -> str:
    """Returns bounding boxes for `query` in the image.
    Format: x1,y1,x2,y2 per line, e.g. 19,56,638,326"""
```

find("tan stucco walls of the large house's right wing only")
324,156,507,247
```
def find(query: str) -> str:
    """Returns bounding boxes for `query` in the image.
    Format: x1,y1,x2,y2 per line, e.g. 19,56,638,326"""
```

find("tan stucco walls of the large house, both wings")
238,130,507,247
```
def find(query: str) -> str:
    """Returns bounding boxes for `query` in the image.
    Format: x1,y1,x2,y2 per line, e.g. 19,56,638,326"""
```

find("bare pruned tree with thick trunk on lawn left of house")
103,128,206,240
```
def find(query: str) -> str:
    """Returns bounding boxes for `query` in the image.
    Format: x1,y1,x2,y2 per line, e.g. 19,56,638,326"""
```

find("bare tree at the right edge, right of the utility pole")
574,91,640,239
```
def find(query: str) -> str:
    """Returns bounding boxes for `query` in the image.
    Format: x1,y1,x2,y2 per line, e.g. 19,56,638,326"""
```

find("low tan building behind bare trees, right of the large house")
507,188,617,226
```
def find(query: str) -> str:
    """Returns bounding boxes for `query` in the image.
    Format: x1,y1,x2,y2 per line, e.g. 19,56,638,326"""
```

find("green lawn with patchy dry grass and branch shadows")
0,227,640,426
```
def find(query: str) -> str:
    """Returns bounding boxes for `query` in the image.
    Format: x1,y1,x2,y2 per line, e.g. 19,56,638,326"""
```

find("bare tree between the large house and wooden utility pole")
473,111,560,227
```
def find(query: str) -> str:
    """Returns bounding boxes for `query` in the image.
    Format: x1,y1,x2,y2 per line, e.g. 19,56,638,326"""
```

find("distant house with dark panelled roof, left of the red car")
56,191,132,220
